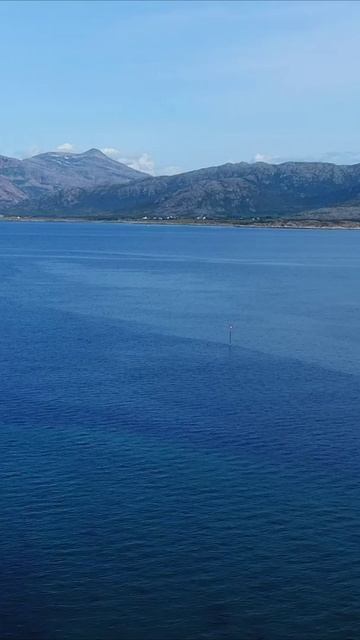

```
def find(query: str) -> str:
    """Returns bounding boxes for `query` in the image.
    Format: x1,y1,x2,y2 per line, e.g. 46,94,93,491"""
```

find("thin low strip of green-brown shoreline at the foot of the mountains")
0,215,360,230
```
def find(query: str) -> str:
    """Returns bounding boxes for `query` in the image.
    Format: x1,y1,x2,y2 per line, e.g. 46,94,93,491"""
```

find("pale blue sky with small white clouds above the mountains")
0,0,360,174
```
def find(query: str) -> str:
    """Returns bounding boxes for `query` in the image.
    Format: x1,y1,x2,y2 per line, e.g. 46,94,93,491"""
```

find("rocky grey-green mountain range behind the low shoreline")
0,149,360,221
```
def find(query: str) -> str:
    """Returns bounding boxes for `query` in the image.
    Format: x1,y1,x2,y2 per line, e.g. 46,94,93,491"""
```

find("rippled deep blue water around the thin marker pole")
0,223,360,640
